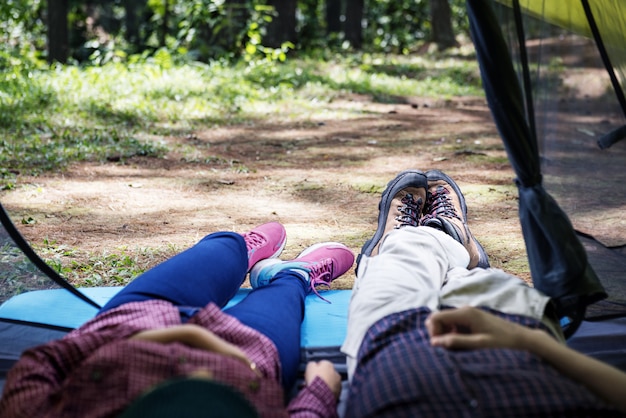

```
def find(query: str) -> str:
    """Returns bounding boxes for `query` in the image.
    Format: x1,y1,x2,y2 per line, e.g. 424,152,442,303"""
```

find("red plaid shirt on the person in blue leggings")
0,300,336,418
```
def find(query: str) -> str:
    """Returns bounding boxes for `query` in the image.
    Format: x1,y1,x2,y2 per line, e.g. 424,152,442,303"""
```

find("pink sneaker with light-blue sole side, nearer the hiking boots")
250,242,354,302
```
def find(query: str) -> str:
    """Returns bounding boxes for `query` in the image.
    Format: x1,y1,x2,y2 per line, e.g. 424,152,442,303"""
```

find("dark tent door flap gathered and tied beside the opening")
467,0,607,333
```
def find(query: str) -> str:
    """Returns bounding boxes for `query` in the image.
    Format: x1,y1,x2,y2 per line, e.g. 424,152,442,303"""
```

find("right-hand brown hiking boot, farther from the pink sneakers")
420,170,489,269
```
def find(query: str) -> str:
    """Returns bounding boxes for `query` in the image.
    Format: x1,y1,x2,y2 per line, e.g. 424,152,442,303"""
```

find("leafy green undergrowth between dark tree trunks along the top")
0,0,468,66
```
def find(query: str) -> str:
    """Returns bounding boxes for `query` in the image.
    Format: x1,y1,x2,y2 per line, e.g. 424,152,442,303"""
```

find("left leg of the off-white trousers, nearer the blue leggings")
341,226,470,379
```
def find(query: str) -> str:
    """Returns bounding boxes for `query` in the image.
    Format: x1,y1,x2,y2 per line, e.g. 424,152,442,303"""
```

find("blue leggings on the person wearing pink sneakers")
99,232,308,389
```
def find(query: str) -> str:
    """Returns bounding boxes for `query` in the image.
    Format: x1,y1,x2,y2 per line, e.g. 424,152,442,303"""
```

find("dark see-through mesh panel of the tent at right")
494,1,626,319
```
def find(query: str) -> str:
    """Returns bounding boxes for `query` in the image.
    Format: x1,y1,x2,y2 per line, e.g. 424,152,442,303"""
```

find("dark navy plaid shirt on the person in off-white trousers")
346,308,623,418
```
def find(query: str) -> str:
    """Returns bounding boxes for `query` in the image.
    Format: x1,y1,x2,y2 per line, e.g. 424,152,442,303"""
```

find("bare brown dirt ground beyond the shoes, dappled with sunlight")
0,96,530,288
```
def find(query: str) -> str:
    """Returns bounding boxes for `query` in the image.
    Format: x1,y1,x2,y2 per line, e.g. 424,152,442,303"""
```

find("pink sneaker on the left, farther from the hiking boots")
241,222,287,271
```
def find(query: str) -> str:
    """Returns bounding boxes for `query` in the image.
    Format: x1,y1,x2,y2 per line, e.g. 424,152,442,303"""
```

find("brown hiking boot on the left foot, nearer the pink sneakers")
357,170,427,264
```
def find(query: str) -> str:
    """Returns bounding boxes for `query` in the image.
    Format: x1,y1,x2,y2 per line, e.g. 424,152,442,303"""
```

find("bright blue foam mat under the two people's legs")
0,287,352,347
